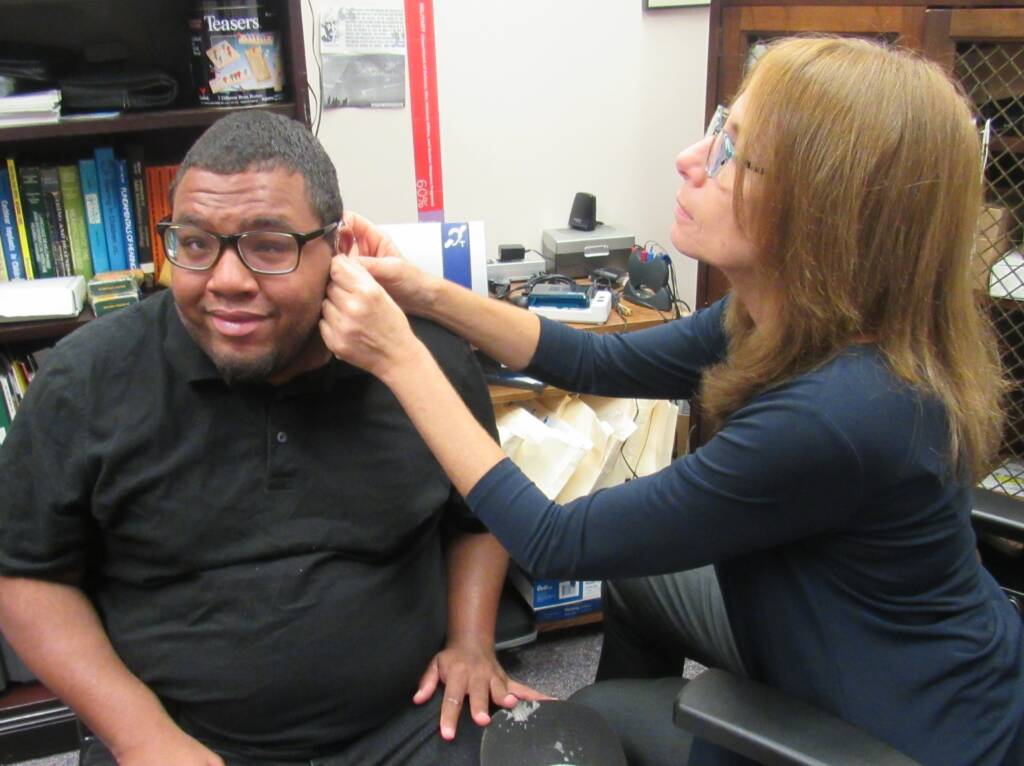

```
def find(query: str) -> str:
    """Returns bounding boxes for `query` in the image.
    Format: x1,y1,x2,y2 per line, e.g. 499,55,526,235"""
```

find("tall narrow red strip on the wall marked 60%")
406,0,444,221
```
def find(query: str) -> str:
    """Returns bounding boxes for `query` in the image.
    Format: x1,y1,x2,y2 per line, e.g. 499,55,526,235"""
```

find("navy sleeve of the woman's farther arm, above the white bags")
526,299,727,398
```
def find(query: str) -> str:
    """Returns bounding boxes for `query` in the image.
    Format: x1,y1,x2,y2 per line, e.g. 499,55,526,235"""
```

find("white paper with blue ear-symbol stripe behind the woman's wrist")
381,221,487,296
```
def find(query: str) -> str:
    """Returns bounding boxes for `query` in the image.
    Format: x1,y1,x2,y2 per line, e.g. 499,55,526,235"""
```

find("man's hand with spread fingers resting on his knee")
413,644,551,739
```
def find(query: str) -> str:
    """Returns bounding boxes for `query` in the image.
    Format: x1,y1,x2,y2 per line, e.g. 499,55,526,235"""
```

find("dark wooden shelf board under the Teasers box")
0,101,295,144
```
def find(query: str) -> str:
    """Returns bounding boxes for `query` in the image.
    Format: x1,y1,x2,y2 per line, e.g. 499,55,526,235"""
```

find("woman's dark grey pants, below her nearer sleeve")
572,566,743,766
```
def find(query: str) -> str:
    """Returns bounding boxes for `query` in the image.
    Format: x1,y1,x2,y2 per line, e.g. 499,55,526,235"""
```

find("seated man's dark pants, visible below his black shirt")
80,689,483,766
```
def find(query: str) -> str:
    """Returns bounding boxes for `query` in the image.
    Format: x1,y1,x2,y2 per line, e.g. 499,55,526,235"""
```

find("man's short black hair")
171,110,343,224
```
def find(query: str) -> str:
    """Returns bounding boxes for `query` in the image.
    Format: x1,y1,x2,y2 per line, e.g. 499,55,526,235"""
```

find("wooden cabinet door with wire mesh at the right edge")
924,8,1024,500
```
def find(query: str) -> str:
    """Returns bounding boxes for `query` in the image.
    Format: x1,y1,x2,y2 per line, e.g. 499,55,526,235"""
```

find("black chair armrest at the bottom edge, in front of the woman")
673,669,920,766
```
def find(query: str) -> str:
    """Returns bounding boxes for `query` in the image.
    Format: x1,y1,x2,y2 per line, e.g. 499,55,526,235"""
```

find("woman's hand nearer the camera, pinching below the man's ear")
319,255,426,382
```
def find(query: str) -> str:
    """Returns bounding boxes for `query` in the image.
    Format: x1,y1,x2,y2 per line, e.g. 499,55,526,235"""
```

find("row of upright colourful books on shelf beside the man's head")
0,149,177,281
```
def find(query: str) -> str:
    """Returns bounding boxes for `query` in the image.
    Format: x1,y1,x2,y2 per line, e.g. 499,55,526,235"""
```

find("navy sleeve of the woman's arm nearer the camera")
467,383,864,580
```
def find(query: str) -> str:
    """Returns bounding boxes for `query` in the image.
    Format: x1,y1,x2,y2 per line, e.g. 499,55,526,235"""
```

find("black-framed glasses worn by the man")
157,219,341,274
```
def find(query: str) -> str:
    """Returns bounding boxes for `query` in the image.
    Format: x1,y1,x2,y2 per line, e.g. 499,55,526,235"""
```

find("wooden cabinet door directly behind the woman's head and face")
697,2,925,306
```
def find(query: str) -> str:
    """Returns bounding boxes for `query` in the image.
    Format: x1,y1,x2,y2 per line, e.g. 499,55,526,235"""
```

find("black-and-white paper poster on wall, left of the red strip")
318,0,406,109
